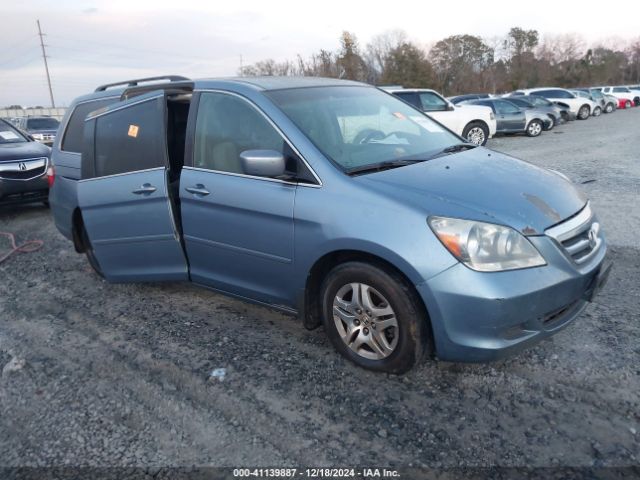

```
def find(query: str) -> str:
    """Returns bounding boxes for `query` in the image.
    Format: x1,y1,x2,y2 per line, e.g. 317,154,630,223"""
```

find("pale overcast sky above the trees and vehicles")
0,0,640,106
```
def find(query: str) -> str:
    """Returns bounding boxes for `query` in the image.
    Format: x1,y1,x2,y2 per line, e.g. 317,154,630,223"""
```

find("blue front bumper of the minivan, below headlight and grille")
417,236,609,362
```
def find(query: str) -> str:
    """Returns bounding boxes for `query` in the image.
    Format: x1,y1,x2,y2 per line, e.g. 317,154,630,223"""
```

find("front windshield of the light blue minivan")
268,86,461,173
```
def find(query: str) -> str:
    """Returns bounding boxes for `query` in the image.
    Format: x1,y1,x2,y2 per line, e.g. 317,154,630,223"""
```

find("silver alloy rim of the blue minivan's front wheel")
333,282,399,360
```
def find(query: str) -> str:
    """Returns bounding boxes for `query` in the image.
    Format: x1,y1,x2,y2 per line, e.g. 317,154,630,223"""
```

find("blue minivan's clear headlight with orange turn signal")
428,217,546,272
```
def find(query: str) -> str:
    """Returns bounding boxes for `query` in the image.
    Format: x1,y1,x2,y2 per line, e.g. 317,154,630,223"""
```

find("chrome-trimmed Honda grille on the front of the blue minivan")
545,203,602,264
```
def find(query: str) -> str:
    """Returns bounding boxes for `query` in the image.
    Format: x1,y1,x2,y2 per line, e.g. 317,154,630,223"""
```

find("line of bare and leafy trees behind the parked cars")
239,27,640,95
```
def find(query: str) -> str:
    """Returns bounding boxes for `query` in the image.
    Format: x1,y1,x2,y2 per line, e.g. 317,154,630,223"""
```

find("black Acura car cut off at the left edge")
0,119,51,205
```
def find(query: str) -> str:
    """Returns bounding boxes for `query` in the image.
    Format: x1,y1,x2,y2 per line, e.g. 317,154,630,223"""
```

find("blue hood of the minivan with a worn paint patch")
355,147,587,235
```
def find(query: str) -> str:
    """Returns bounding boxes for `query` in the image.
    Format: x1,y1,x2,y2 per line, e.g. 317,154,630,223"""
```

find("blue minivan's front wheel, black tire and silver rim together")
321,261,430,374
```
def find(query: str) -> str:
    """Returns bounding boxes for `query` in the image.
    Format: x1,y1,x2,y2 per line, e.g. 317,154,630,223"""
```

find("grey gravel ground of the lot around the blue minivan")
0,108,640,468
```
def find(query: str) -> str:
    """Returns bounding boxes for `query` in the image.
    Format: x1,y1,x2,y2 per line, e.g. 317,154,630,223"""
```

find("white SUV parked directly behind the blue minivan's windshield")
382,87,496,145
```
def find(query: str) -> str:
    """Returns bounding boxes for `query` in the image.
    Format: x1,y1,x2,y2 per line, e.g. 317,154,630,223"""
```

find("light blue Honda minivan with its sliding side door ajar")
50,76,610,373
